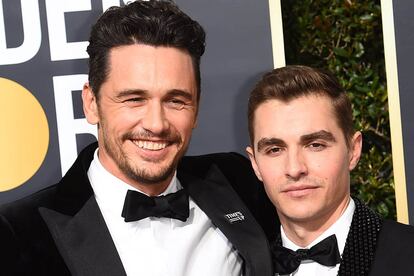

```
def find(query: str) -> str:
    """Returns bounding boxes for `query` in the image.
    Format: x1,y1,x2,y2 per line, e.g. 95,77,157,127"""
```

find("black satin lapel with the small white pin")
178,165,271,275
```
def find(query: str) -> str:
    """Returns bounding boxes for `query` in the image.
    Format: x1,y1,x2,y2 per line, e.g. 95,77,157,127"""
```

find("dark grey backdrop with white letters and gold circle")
0,0,284,204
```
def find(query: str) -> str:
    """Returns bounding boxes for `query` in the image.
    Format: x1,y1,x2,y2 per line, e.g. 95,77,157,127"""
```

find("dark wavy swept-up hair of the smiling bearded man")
87,0,205,99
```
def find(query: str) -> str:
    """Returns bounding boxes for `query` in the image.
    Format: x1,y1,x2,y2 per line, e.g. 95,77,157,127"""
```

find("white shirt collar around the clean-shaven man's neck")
280,198,355,255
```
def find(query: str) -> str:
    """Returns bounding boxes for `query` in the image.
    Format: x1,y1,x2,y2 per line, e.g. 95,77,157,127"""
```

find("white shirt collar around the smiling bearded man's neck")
88,149,182,216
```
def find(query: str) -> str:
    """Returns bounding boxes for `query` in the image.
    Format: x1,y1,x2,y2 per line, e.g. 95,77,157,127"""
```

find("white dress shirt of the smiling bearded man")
88,150,242,276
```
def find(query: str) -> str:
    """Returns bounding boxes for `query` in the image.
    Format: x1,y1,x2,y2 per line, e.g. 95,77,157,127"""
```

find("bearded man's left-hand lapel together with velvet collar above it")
39,143,126,276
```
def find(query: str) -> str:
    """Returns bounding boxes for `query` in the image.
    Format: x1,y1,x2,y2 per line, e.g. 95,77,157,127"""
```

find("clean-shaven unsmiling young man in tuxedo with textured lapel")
247,66,414,276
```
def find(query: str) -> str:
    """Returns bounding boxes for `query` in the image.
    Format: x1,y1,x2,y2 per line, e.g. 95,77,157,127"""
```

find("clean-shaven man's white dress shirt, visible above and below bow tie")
280,198,355,276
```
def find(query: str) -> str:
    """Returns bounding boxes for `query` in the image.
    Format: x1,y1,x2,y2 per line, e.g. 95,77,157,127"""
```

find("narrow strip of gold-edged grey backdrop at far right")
381,0,414,225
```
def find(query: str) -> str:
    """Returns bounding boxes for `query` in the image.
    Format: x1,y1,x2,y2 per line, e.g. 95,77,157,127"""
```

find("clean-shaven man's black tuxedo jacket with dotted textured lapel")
338,199,414,276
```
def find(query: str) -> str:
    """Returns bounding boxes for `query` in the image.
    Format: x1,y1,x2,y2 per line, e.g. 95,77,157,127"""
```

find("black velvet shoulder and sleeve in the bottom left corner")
0,186,70,275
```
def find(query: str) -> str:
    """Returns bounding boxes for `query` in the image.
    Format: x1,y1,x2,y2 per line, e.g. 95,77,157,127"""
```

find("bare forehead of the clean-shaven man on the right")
254,96,341,142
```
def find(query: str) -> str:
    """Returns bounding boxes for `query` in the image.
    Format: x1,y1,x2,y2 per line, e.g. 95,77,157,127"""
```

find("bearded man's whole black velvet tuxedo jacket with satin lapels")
0,144,279,276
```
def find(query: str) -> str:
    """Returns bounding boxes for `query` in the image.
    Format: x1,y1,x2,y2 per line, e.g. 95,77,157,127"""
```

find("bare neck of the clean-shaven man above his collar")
279,196,350,247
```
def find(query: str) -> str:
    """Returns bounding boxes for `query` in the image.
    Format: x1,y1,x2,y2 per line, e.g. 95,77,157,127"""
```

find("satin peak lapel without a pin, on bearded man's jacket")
39,196,126,276
